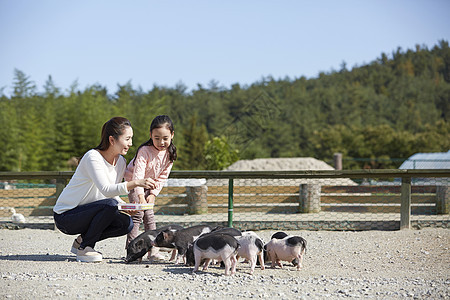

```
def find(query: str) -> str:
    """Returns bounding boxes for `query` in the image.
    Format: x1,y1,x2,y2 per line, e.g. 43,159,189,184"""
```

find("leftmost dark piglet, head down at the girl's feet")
125,224,183,263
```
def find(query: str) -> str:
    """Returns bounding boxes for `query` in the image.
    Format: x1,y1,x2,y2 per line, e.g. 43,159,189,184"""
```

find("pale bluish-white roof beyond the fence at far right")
399,150,450,169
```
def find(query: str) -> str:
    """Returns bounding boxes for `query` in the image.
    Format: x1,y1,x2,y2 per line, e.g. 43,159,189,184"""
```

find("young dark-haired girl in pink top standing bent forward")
125,115,177,254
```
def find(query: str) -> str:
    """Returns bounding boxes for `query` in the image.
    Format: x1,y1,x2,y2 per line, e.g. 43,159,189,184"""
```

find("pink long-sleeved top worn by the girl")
124,146,173,196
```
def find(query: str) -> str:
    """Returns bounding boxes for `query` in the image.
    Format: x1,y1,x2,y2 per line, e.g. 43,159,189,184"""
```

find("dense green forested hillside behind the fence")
0,40,450,171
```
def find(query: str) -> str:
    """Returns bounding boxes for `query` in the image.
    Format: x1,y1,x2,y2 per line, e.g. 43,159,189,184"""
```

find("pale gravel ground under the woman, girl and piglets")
0,228,450,299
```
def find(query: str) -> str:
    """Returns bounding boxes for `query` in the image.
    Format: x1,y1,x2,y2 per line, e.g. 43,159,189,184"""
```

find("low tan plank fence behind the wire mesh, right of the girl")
149,185,450,215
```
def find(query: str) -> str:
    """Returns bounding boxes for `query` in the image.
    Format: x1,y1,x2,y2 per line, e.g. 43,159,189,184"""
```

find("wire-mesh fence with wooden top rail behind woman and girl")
0,170,450,229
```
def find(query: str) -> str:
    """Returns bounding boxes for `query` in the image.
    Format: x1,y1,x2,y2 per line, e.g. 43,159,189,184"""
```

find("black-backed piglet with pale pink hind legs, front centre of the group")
193,233,239,275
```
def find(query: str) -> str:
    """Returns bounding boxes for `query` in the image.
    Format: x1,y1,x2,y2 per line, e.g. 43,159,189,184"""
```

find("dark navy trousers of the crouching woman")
53,199,133,248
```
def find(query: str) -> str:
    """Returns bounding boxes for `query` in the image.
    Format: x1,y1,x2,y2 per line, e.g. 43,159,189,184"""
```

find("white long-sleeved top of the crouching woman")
53,149,128,214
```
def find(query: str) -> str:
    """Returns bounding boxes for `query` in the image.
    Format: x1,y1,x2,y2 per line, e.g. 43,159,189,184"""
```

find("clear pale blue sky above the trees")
0,0,450,95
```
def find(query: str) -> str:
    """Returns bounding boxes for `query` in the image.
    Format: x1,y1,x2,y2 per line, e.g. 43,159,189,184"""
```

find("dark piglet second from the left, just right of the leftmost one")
152,225,211,264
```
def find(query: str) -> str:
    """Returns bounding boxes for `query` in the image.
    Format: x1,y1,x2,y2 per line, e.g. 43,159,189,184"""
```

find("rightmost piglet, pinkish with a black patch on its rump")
265,236,306,270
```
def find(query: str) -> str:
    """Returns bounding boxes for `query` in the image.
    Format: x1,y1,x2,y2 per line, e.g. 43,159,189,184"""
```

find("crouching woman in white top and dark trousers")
53,117,155,262
